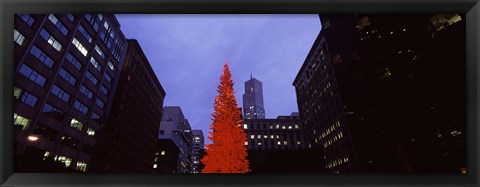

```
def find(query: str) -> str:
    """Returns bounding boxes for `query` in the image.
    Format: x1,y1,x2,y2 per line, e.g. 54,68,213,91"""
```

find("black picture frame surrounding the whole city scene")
0,0,480,186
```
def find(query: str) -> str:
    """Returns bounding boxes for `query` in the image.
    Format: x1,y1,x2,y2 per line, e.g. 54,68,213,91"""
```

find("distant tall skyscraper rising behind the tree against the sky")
243,75,265,119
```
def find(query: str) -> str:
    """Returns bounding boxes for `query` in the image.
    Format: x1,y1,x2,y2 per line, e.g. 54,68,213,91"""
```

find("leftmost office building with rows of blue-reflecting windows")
13,14,127,172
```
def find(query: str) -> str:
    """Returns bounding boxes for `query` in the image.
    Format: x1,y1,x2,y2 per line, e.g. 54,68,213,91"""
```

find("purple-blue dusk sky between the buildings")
116,14,321,143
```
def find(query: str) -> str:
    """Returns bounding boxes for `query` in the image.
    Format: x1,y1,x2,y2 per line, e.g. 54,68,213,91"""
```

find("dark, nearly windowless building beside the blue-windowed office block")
95,40,166,173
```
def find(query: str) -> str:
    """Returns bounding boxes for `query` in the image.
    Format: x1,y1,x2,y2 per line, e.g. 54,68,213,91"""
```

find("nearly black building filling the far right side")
320,14,466,173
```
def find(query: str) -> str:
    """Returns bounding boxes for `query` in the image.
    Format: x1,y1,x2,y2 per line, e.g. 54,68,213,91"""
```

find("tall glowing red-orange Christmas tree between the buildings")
201,62,250,173
